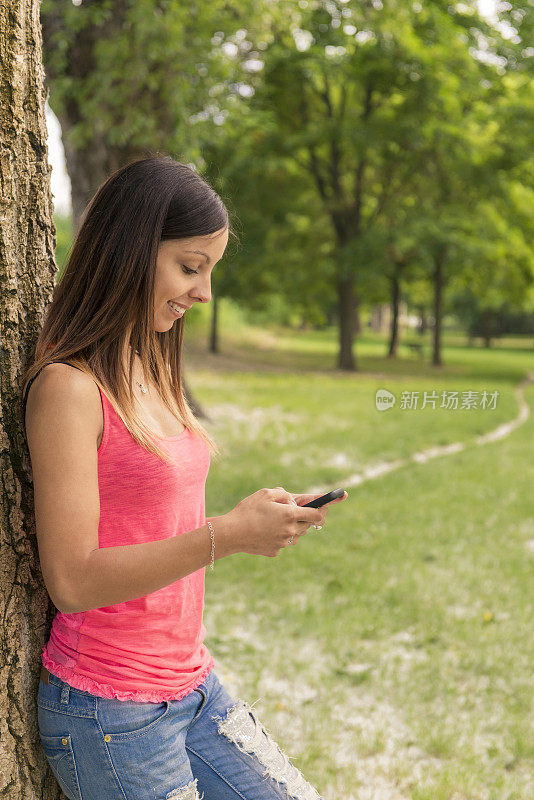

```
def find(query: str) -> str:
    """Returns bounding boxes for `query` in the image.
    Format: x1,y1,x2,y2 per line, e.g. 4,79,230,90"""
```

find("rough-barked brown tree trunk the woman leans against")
0,0,67,800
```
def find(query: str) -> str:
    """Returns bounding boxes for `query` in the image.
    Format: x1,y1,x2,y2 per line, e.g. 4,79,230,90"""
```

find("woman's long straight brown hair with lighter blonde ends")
23,156,235,463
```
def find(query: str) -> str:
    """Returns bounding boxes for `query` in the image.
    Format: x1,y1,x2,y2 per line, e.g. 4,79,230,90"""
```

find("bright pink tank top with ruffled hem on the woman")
42,382,214,703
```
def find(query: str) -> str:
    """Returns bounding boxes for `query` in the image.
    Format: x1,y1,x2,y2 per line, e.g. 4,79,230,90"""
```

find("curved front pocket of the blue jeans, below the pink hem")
97,697,170,742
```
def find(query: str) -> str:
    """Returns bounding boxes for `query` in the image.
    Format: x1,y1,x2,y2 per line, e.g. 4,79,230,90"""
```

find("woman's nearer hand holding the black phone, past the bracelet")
225,486,326,558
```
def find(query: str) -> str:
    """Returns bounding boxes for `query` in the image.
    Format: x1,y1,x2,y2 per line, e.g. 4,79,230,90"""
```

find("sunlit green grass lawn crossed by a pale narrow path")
185,307,534,800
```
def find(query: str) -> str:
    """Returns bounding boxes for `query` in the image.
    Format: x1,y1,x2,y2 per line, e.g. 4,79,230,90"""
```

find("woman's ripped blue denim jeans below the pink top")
37,669,321,800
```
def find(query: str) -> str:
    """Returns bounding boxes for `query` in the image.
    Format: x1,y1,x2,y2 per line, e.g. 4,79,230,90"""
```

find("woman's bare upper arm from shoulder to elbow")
26,364,102,612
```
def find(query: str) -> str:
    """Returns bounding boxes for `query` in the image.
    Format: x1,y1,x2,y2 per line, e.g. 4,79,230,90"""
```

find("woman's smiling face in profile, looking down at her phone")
154,228,228,333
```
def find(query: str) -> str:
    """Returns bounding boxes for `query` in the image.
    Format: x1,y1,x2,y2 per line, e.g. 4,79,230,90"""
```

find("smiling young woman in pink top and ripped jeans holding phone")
23,157,346,800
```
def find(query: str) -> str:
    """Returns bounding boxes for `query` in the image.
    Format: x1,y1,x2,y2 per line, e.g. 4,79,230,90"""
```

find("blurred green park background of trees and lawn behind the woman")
41,0,534,800
